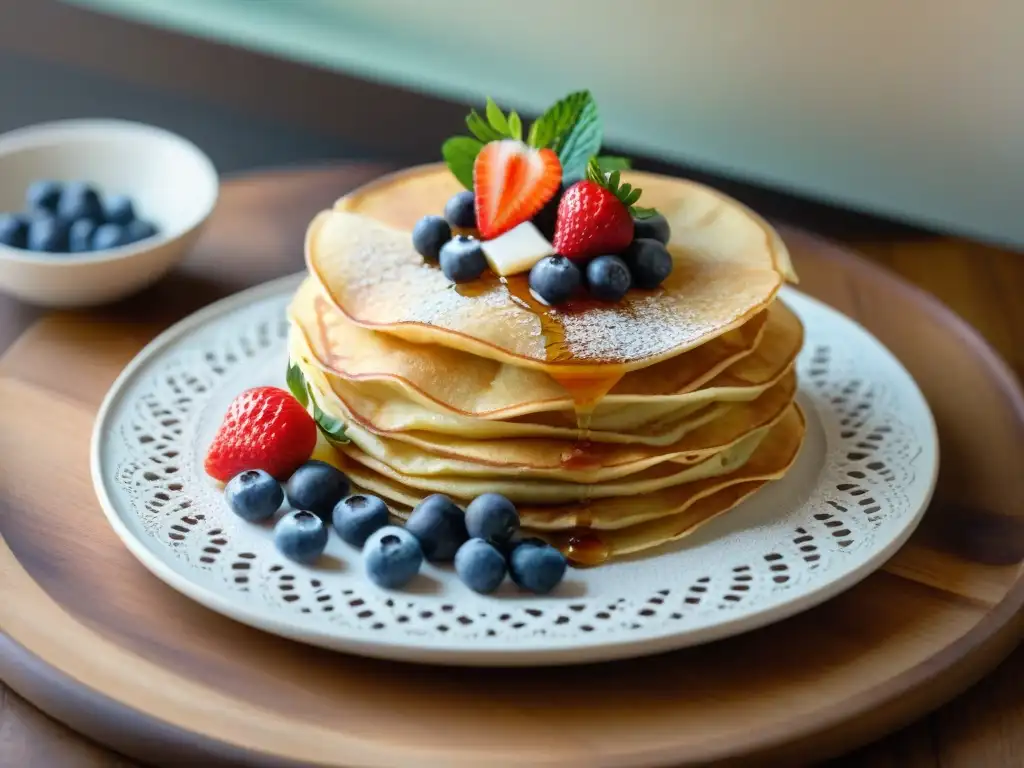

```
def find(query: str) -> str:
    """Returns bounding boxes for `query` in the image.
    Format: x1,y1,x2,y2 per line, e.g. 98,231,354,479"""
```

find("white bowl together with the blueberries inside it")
0,120,219,307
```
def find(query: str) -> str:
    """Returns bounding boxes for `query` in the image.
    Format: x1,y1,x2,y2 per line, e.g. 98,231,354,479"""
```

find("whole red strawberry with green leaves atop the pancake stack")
553,159,653,261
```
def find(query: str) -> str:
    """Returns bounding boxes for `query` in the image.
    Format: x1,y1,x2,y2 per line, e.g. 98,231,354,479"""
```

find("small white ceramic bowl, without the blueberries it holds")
0,120,219,307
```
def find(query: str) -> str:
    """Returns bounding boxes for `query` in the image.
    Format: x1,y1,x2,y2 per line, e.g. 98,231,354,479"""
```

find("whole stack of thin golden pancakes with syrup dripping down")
290,166,804,564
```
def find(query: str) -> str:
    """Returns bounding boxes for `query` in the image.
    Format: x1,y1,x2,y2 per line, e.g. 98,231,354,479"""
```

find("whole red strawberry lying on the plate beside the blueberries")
205,387,316,482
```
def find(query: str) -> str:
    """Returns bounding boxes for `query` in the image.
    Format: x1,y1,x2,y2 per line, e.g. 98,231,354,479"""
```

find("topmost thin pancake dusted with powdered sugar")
306,166,795,382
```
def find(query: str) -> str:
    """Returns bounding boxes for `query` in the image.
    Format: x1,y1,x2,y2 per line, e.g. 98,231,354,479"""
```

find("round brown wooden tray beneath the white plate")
0,168,1024,767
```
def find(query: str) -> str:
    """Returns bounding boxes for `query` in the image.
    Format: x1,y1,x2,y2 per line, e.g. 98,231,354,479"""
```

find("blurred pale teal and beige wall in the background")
66,0,1024,245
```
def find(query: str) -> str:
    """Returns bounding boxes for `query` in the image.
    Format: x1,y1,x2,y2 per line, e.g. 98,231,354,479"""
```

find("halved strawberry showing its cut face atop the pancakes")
473,138,562,240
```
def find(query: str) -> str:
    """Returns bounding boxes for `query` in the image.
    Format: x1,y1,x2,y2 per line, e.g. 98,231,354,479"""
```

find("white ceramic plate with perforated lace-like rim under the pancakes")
92,276,938,666
